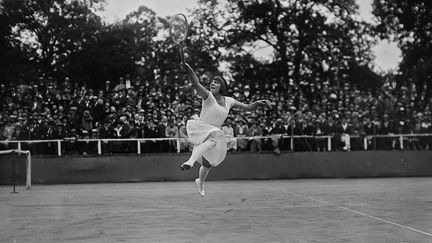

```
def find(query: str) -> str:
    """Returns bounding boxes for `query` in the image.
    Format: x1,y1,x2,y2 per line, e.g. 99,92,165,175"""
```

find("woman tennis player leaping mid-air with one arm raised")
181,63,271,196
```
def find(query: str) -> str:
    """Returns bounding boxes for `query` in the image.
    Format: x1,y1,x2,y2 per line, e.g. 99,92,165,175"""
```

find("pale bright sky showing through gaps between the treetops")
98,0,401,71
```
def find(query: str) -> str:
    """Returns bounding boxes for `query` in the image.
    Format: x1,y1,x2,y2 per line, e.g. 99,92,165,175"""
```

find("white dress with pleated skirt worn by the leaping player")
186,92,235,166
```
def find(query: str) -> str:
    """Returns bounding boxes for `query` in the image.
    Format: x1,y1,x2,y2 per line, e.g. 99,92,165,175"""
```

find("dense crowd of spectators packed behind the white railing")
0,72,432,154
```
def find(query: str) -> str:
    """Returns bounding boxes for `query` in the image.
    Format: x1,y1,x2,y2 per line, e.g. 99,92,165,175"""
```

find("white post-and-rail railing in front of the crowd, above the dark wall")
0,133,432,156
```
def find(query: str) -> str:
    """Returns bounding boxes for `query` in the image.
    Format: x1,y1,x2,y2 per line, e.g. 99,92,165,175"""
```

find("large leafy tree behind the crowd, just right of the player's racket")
189,0,374,100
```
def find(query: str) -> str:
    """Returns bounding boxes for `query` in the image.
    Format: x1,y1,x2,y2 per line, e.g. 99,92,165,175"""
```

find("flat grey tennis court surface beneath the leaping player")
0,178,432,242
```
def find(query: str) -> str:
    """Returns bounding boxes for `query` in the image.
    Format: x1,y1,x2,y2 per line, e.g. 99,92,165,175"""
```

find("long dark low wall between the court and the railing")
0,151,432,184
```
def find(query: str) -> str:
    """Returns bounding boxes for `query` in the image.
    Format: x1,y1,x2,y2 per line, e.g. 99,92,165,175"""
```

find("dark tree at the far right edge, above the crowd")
373,0,432,108
